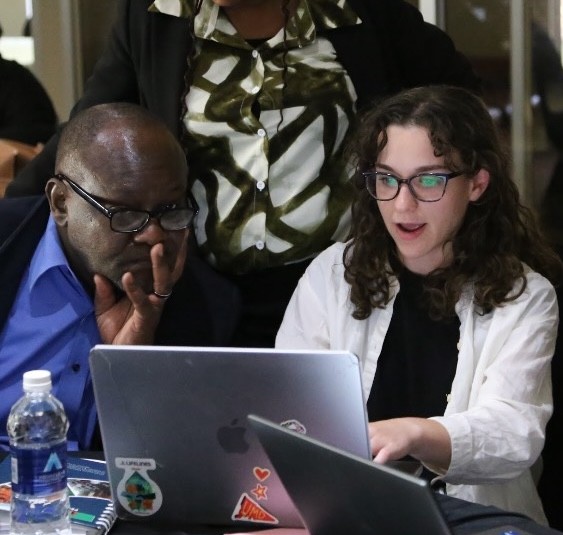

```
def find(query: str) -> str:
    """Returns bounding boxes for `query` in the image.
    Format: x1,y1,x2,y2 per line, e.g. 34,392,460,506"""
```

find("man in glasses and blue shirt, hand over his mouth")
0,103,240,449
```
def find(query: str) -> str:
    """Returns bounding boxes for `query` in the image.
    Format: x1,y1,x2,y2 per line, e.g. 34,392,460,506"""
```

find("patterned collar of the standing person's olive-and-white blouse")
149,0,362,45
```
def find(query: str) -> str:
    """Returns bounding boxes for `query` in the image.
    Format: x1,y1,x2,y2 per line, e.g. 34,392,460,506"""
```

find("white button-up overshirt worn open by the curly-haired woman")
276,243,559,524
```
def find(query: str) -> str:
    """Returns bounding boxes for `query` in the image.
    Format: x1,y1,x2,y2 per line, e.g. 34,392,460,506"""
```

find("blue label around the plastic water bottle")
11,441,66,495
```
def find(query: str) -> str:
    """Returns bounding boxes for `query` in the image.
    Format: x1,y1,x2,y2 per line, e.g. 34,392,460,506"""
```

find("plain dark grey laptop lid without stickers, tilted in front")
248,415,451,535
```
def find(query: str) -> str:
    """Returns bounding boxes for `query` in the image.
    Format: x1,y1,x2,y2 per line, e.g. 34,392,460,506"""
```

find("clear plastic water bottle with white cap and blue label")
7,370,71,535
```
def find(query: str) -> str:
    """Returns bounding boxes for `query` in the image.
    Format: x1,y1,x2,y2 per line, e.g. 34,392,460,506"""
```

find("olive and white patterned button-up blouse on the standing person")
150,0,361,273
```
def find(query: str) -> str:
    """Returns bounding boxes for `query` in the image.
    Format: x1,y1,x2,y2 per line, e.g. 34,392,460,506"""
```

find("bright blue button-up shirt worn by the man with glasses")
0,218,101,449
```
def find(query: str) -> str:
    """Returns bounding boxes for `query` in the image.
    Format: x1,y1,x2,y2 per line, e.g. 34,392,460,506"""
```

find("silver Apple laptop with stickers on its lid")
90,345,370,529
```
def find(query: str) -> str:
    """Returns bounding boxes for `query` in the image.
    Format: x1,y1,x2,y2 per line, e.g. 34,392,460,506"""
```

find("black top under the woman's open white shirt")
367,270,459,422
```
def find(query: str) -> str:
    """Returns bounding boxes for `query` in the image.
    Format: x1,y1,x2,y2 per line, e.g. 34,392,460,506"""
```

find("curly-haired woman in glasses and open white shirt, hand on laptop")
276,86,561,523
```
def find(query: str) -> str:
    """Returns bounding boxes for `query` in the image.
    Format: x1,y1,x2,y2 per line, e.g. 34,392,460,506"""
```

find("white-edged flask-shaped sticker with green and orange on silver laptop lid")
115,457,162,516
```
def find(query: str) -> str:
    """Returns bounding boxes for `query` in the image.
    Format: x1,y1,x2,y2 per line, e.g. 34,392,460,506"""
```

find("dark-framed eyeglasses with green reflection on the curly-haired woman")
362,171,463,202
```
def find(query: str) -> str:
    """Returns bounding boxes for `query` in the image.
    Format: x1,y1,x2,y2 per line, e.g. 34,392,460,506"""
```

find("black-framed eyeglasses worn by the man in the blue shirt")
54,173,197,232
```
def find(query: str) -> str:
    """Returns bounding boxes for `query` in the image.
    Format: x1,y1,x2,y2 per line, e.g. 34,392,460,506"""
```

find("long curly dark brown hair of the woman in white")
344,86,563,319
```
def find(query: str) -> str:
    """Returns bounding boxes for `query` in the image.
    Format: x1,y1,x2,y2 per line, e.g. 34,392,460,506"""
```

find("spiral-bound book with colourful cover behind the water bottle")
0,455,116,535
